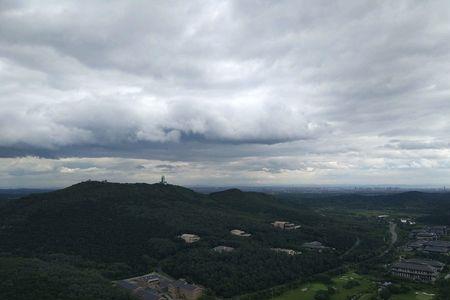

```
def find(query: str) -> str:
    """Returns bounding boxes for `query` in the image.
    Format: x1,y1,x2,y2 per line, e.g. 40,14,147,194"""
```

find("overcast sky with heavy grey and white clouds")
0,0,450,187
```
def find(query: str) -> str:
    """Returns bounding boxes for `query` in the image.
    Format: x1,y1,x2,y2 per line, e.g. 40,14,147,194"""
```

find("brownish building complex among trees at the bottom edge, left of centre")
117,273,204,300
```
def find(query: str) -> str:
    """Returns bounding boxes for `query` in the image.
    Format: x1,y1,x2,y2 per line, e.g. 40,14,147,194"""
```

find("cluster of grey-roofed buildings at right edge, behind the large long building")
405,226,450,254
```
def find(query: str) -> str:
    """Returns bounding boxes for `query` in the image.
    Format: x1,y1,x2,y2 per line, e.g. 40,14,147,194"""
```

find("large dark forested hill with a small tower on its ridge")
0,181,384,298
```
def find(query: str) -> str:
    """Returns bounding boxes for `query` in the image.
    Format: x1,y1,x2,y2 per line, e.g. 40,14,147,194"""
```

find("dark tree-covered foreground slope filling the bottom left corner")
0,256,134,300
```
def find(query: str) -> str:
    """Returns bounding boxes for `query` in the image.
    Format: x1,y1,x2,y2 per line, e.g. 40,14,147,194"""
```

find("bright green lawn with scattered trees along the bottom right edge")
273,272,433,300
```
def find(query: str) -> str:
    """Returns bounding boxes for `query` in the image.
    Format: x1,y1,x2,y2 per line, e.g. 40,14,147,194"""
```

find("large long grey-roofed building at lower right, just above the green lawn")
391,259,445,282
